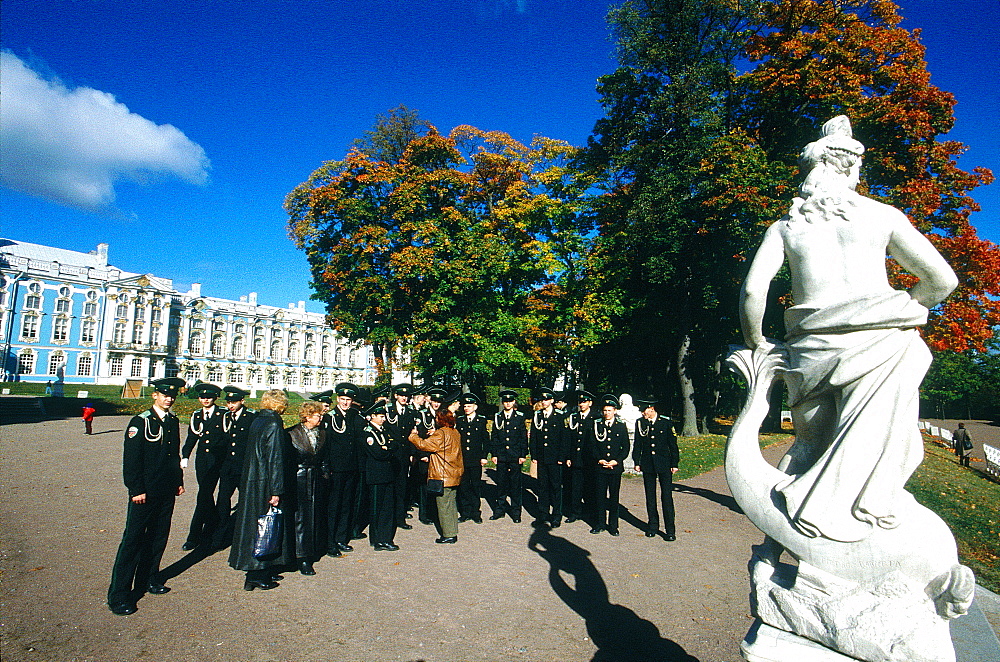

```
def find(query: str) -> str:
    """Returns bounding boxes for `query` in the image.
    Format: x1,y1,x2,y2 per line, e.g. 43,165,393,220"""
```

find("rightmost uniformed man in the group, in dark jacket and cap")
635,400,680,540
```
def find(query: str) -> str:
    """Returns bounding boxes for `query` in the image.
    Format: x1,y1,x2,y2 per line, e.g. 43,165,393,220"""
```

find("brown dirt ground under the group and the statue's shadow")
0,417,992,662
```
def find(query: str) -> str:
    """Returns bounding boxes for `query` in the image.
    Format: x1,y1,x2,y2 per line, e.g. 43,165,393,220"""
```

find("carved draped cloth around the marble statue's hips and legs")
776,290,931,542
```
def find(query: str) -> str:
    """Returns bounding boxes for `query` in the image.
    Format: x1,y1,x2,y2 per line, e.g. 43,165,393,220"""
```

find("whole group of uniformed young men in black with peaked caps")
108,378,679,614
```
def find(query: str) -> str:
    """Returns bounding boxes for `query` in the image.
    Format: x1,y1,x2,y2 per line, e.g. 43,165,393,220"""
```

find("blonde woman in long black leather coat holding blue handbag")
229,390,295,591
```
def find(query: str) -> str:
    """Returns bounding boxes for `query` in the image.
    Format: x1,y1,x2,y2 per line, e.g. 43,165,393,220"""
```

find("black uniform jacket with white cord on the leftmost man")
122,408,184,497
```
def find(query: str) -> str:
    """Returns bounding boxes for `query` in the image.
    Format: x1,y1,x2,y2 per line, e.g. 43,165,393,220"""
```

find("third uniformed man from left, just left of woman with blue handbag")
212,386,256,549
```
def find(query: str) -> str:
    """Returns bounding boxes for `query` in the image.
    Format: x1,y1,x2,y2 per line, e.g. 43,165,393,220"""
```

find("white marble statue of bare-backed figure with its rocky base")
726,116,975,662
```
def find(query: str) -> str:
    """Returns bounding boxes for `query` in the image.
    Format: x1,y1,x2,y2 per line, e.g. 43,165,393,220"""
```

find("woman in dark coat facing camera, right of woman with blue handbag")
288,400,329,575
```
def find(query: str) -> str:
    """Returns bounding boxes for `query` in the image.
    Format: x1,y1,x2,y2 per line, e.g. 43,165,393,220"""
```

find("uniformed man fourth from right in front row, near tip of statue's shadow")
528,388,569,528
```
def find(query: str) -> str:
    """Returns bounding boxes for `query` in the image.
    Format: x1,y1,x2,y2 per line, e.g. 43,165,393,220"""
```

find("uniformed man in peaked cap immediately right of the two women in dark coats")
325,382,365,556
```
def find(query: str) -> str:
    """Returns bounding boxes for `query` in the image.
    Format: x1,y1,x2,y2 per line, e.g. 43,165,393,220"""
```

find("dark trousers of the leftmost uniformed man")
108,495,176,605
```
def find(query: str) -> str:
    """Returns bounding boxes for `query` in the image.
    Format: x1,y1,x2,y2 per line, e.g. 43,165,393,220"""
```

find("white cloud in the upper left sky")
0,51,209,212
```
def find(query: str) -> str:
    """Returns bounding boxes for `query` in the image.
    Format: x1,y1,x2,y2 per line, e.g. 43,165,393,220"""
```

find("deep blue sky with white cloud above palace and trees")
0,0,1000,312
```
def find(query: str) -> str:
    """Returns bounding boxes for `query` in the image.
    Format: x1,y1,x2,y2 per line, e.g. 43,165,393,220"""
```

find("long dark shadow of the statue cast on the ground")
528,529,698,662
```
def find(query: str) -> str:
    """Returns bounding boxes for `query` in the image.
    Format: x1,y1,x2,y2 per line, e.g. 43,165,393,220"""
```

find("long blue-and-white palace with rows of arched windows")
0,239,390,391
